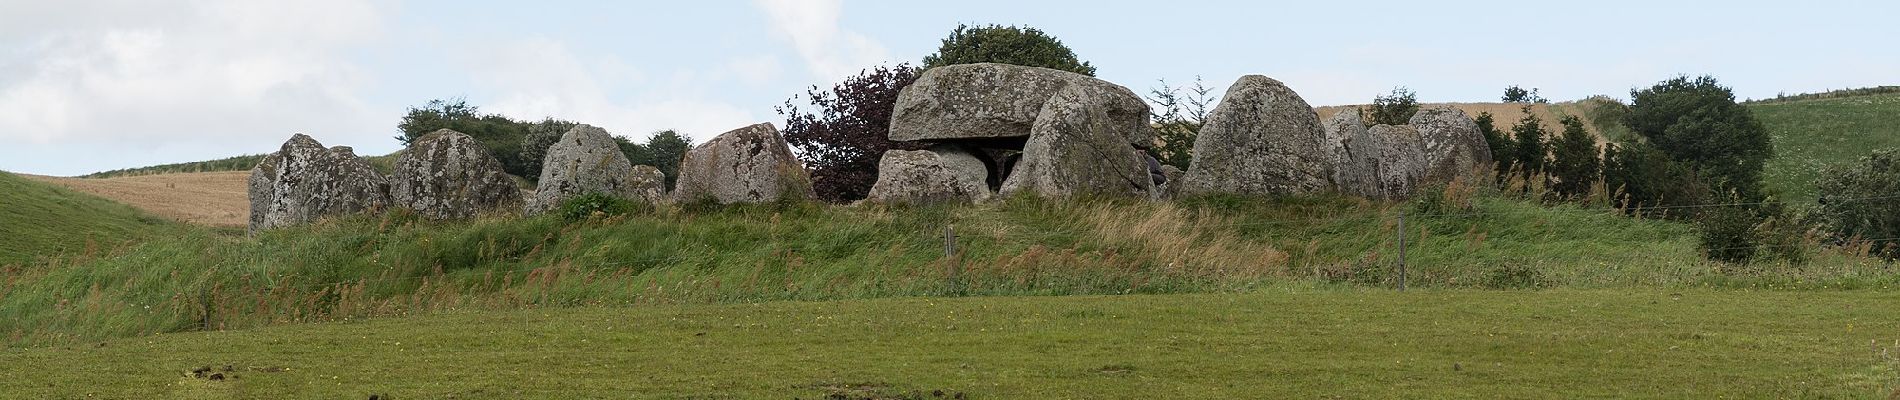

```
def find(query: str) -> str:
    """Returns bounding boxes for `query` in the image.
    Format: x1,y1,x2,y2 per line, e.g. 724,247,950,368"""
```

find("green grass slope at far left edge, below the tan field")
0,173,165,267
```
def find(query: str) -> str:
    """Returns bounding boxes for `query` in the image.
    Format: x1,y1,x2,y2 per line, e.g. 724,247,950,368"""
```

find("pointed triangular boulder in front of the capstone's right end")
999,85,1155,199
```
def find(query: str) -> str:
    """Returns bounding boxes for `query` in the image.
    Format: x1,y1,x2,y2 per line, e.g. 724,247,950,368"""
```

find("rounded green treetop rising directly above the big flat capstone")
923,25,1094,76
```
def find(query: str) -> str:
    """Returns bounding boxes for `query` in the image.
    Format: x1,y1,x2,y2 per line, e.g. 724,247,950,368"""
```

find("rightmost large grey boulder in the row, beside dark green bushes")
1406,106,1493,186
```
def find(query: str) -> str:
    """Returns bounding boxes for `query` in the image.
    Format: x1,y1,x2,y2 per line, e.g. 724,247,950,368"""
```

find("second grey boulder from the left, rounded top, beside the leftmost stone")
390,129,521,220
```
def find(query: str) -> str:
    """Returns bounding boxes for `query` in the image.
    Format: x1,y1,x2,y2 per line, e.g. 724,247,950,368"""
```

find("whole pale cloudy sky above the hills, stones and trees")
0,0,1900,174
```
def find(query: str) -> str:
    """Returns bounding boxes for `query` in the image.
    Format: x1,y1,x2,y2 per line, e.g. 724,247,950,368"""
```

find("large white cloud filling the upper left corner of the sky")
0,0,386,144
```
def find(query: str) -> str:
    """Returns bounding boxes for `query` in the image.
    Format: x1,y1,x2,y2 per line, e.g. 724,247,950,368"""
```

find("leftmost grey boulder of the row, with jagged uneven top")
249,133,390,231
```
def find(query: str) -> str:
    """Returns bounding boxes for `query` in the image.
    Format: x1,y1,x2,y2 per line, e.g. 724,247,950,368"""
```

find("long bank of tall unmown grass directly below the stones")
0,182,1894,343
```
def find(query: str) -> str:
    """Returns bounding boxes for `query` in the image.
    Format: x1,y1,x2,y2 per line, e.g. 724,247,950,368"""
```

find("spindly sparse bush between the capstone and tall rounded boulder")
1148,76,1216,171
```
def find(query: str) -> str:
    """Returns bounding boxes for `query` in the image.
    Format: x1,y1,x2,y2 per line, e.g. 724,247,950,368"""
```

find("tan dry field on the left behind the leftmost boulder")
23,171,251,227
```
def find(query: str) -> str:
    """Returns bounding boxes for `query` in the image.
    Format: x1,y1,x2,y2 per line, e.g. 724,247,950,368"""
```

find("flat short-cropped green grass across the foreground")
0,288,1900,398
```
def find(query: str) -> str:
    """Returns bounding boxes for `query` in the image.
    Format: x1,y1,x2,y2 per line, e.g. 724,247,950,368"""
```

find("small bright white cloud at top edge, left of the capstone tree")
758,0,891,82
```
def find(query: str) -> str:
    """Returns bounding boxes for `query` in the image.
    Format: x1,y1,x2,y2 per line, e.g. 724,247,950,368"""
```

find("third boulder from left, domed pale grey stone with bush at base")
526,125,640,214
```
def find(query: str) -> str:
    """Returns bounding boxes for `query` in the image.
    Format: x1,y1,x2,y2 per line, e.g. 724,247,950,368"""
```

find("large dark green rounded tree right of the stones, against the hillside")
1623,76,1775,201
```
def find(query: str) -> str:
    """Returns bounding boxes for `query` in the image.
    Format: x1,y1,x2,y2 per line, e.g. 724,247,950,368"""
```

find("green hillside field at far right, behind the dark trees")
1748,93,1900,201
